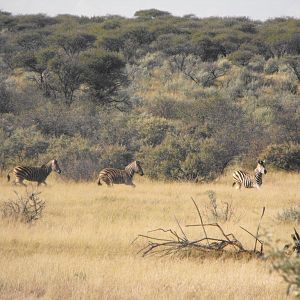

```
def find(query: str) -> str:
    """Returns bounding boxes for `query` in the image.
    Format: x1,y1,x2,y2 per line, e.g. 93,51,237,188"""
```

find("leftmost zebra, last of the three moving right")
7,159,61,186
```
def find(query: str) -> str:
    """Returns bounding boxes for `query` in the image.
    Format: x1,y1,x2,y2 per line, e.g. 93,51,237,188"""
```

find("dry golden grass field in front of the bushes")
0,172,300,299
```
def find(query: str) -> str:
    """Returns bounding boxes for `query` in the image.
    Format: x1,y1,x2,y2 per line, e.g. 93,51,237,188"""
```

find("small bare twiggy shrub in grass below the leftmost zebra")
0,192,45,223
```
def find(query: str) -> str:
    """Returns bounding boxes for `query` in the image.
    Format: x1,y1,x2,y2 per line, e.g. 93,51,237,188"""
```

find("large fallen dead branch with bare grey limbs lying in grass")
133,198,265,257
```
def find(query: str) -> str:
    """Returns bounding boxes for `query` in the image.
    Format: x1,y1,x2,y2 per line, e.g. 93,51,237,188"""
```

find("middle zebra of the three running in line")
97,160,144,187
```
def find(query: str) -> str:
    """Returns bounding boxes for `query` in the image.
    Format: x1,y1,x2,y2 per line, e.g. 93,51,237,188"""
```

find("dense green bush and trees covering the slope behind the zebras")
0,9,300,180
